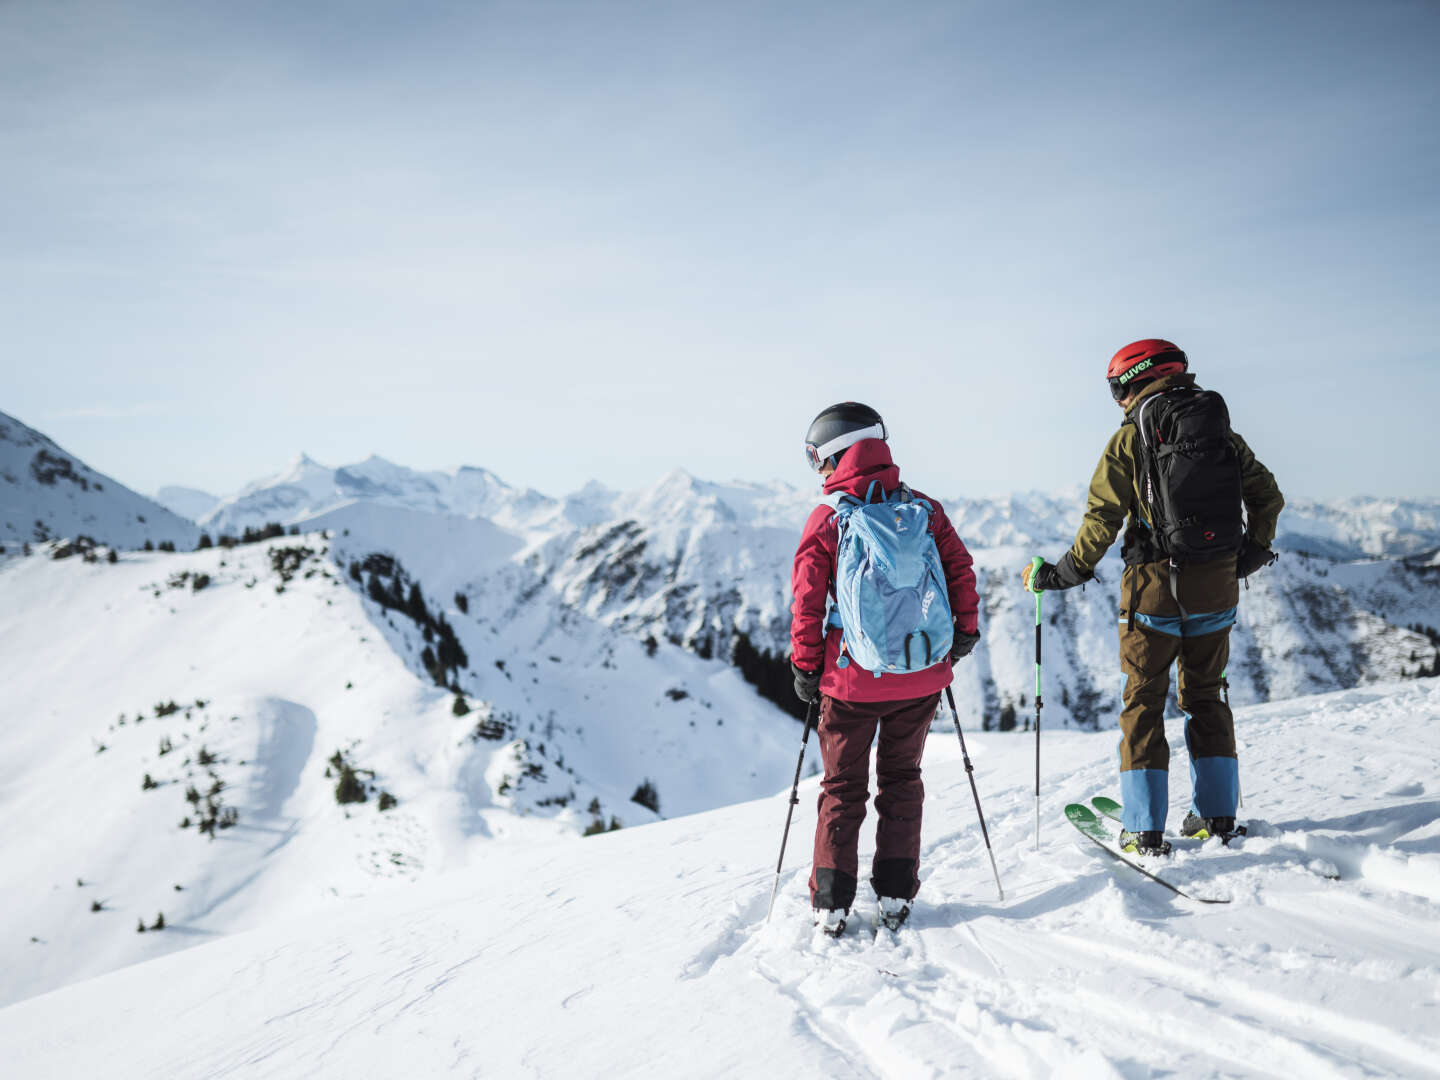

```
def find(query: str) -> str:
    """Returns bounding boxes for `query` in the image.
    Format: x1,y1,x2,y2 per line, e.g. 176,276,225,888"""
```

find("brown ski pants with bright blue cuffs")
1120,556,1240,832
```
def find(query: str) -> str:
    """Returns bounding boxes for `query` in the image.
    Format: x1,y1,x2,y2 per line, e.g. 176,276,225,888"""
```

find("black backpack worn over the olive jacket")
1126,386,1246,564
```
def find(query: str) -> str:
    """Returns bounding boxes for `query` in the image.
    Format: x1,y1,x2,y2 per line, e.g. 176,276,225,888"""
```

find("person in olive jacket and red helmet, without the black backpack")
1021,338,1284,854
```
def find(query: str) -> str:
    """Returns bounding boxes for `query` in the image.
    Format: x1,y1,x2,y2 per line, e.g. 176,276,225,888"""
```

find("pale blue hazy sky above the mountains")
0,0,1440,497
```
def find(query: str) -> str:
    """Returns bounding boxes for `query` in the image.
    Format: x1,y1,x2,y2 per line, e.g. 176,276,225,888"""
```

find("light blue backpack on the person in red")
831,484,953,678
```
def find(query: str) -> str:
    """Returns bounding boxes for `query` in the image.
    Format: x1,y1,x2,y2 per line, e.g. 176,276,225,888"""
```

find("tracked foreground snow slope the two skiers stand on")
0,680,1440,1079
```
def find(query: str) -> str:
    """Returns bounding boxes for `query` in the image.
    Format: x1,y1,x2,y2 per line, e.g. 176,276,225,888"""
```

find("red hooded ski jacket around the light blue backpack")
791,439,979,701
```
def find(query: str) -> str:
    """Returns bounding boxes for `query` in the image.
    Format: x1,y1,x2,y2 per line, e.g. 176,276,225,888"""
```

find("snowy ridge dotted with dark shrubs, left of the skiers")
0,538,796,1013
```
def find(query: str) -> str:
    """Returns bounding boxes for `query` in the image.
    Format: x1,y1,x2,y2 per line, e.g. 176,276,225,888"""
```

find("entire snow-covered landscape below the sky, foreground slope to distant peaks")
8,416,1440,1080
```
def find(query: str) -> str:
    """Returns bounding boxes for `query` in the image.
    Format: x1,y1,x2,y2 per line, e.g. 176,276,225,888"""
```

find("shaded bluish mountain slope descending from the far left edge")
0,412,200,549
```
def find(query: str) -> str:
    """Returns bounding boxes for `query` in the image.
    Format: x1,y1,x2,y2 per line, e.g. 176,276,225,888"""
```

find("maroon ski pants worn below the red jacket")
809,694,940,909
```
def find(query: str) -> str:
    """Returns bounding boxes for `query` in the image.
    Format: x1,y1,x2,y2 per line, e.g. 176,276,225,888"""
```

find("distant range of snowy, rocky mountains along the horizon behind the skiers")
8,408,1440,726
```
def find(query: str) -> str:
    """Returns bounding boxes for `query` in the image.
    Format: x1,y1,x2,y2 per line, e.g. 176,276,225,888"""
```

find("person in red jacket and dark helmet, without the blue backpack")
791,402,979,935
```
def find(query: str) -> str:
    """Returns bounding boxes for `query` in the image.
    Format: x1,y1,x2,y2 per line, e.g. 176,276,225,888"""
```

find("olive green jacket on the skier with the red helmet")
1067,374,1284,579
